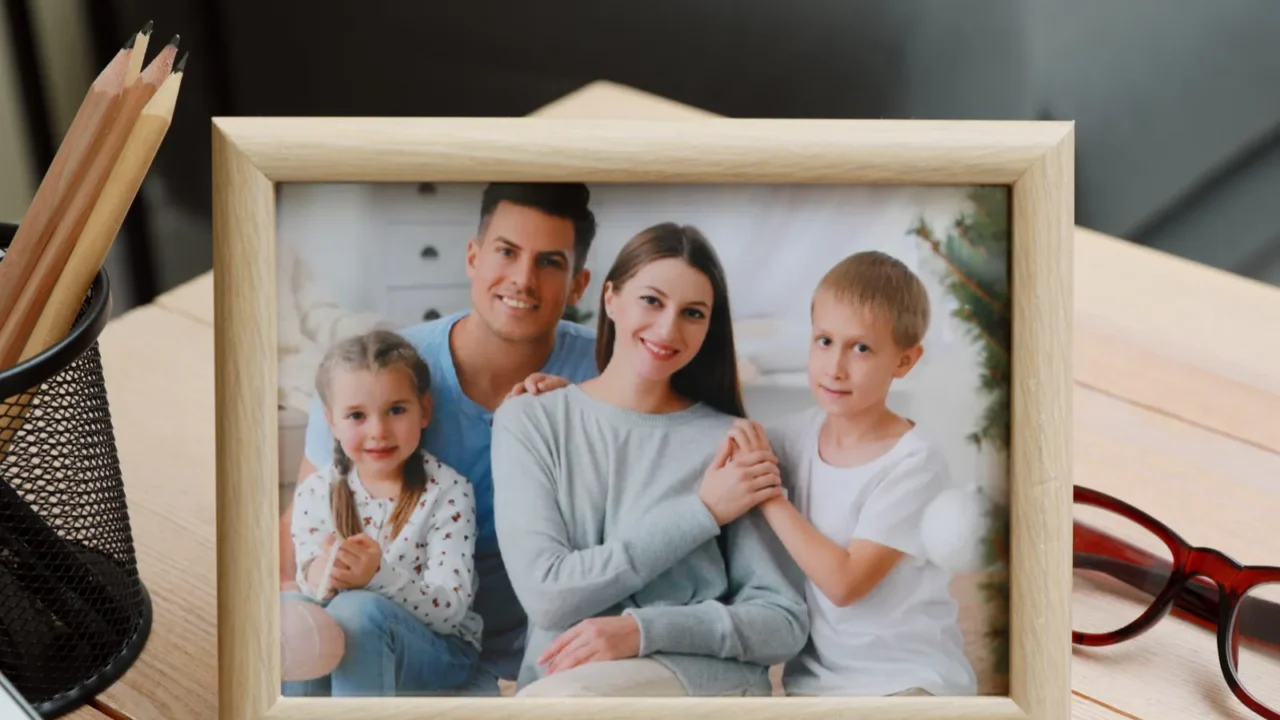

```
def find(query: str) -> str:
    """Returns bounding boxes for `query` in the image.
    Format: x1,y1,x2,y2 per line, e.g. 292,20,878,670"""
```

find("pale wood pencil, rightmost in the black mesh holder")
19,55,187,363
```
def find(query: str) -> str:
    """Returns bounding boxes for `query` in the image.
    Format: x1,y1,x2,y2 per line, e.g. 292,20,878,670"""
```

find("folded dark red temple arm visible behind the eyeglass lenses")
1075,523,1280,650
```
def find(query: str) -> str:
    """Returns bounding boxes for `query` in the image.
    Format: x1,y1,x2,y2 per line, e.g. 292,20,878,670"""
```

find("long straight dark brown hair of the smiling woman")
595,223,746,418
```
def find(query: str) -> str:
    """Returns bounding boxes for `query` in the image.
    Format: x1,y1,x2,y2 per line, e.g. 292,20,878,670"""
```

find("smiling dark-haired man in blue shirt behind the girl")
280,183,598,694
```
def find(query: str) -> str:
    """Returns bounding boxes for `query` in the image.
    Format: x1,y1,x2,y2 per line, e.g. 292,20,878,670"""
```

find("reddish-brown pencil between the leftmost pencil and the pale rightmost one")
0,36,178,370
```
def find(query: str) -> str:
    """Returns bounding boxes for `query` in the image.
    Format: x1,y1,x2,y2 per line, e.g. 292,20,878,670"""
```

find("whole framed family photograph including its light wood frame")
214,118,1074,720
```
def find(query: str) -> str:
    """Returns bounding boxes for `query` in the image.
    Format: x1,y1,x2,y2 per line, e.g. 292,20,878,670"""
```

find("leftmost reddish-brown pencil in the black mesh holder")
0,38,134,340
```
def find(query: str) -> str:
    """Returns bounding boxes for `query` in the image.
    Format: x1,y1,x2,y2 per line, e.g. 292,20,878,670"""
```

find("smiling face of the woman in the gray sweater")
604,258,714,379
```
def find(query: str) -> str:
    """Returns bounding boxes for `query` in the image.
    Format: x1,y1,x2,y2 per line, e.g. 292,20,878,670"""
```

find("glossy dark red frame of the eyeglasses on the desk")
1071,486,1280,720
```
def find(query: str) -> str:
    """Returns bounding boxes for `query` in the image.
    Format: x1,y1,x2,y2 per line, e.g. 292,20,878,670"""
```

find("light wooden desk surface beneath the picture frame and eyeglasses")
77,83,1280,720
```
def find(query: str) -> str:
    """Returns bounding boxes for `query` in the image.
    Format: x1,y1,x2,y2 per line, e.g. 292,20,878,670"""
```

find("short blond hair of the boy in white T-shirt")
814,250,929,350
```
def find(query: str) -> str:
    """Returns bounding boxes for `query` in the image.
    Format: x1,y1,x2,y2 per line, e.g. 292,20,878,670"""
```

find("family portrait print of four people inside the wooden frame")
267,176,1011,698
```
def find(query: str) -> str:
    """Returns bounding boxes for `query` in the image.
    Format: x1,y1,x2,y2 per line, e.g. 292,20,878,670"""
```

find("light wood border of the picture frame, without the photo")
212,117,1075,720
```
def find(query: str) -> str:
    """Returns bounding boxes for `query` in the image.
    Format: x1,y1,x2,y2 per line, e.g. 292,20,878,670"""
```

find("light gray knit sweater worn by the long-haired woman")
493,386,809,696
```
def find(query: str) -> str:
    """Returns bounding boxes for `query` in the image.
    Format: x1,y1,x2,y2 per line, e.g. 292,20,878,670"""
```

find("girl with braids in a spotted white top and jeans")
284,331,481,696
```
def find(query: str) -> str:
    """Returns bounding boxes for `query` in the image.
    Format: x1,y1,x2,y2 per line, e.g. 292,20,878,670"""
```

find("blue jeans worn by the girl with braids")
282,591,498,697
